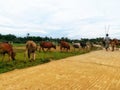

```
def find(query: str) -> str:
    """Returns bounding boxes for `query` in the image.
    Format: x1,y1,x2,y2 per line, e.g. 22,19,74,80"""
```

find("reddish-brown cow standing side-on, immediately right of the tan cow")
39,41,56,51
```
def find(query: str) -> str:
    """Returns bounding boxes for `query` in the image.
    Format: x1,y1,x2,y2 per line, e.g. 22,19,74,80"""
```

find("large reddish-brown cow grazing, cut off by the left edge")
0,43,15,61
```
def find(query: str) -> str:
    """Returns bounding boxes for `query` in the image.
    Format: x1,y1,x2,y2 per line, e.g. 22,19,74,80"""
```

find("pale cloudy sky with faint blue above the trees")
0,0,120,39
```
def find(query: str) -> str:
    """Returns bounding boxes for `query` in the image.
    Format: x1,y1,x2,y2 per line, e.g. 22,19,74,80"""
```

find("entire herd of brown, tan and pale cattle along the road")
0,39,120,61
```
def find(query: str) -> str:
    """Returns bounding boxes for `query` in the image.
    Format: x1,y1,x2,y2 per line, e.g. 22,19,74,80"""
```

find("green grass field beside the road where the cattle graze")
0,44,100,73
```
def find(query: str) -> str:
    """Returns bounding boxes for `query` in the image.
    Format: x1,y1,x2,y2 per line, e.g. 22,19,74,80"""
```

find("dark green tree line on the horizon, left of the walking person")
0,34,103,43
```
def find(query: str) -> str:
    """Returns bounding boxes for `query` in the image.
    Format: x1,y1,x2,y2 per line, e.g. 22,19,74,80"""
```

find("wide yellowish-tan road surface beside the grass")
0,50,120,90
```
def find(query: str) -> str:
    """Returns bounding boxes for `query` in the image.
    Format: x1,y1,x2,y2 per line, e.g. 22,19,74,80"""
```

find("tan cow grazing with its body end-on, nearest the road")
25,40,37,61
